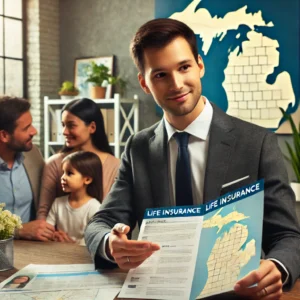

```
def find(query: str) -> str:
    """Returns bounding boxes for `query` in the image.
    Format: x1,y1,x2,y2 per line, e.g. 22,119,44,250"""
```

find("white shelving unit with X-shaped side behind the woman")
44,94,139,159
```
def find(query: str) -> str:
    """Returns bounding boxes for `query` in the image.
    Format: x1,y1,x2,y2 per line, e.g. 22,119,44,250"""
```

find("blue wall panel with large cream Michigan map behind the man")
155,0,300,133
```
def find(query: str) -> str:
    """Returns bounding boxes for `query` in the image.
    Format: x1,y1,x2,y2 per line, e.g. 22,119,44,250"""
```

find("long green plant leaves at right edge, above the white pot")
279,107,300,183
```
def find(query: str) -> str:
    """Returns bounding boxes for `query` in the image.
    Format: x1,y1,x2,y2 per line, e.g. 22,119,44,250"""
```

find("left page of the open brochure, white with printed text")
119,206,203,300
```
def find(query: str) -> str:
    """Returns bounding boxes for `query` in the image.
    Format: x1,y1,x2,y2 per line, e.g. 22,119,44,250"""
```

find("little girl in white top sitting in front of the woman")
47,151,103,245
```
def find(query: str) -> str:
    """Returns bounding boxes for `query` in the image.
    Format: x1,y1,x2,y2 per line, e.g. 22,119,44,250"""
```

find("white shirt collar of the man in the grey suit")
164,96,213,141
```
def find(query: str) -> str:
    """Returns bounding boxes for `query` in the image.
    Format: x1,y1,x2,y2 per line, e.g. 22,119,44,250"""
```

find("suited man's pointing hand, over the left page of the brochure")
106,223,160,270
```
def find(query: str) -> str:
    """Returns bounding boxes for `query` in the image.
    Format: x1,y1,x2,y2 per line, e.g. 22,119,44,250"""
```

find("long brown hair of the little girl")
61,151,103,203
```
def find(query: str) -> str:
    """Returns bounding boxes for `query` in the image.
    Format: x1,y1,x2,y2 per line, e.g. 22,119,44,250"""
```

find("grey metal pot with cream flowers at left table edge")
0,203,22,271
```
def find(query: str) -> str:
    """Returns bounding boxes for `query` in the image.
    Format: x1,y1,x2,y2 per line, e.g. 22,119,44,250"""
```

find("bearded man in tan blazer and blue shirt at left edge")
0,97,54,241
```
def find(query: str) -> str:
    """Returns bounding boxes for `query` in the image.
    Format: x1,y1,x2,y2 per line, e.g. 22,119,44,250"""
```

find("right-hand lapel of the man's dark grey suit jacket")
203,103,236,202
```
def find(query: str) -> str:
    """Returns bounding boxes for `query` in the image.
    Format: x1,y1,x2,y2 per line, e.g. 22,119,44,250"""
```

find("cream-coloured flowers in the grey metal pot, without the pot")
0,203,22,240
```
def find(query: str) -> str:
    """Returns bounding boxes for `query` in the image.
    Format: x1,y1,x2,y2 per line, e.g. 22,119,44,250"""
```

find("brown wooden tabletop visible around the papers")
0,241,300,300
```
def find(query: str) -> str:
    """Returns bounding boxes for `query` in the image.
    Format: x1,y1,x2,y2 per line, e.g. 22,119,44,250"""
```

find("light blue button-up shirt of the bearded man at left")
0,153,33,223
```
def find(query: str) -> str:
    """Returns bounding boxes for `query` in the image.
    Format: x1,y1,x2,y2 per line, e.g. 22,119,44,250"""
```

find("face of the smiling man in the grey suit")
139,37,204,125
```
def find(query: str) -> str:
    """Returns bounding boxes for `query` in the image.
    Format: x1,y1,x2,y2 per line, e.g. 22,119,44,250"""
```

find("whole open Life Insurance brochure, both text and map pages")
119,180,264,300
